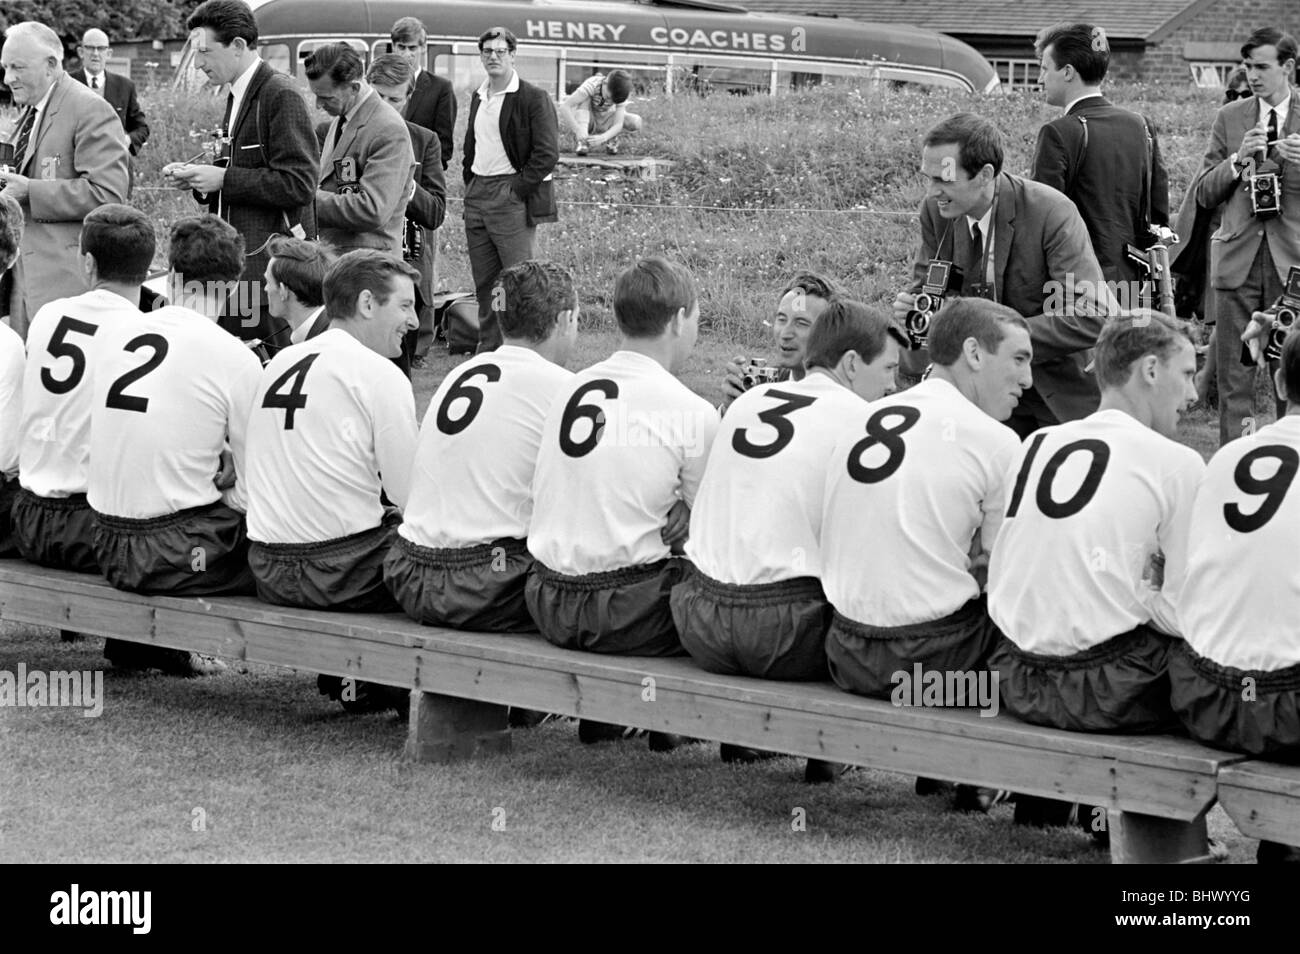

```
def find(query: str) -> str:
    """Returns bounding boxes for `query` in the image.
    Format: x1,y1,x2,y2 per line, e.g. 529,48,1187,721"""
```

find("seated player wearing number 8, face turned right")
822,298,1034,810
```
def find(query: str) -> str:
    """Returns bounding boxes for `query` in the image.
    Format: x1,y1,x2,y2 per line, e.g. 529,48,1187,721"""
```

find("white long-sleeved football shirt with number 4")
247,328,419,543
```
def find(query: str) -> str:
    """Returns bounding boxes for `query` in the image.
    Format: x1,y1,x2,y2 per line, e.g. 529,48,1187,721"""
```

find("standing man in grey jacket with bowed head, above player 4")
303,43,415,256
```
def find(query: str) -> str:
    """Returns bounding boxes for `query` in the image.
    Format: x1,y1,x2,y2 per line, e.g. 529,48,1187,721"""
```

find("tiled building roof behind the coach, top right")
738,0,1216,43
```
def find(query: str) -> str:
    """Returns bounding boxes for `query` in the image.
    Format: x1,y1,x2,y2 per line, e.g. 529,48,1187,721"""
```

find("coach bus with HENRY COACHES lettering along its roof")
181,0,1000,97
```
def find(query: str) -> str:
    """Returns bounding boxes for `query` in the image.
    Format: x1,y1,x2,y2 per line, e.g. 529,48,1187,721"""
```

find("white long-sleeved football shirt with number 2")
87,305,261,520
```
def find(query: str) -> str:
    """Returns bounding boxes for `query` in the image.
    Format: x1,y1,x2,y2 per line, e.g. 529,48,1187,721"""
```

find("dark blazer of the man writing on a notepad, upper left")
196,62,320,302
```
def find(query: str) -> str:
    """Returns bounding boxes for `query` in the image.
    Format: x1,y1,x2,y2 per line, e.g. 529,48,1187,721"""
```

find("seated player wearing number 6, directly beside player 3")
525,259,718,747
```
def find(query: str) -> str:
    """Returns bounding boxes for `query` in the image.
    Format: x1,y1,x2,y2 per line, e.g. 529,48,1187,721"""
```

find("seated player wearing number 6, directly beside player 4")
384,261,579,633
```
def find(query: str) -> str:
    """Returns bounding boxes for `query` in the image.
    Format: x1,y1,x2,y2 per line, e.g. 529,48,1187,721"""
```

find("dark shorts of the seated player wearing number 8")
826,597,1001,704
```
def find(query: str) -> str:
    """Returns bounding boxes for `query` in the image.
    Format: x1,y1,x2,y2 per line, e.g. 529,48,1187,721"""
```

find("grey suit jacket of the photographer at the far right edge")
1192,87,1300,290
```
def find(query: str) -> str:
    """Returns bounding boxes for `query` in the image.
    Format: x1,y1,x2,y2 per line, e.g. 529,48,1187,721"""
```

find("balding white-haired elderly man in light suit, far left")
0,22,127,338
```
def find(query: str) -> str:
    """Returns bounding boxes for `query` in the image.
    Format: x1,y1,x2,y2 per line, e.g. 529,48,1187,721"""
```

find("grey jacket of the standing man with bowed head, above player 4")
316,90,415,256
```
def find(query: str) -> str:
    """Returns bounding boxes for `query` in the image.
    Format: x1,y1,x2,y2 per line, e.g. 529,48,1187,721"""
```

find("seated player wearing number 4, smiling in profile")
239,250,410,708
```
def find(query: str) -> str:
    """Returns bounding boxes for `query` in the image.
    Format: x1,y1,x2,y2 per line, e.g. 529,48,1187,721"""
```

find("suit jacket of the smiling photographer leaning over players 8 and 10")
911,172,1112,421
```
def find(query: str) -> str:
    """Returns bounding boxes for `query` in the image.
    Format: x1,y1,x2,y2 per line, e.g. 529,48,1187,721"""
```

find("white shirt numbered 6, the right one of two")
528,351,718,576
